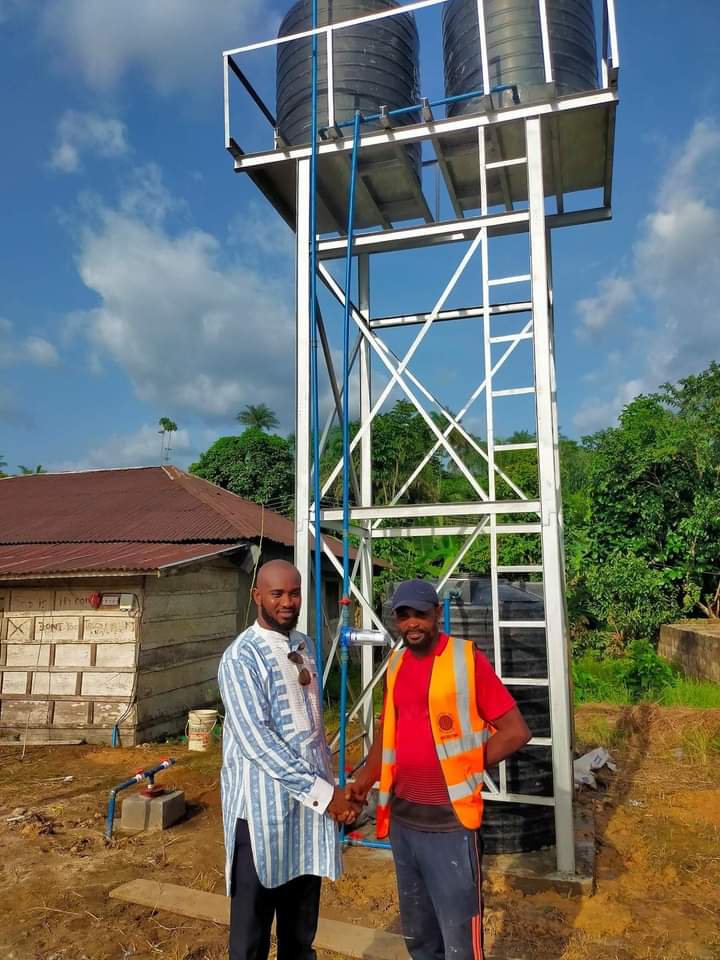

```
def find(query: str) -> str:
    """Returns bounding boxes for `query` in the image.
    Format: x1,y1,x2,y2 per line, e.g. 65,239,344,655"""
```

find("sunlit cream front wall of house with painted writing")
0,578,143,742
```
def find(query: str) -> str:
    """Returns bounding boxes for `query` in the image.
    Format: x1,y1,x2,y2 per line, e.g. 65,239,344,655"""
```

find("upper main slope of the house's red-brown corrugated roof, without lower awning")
0,467,294,546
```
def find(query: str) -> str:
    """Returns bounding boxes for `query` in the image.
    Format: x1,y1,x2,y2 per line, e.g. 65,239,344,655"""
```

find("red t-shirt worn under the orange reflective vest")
395,633,515,804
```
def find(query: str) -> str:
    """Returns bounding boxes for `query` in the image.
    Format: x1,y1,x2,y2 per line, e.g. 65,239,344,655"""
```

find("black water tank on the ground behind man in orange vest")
383,576,555,853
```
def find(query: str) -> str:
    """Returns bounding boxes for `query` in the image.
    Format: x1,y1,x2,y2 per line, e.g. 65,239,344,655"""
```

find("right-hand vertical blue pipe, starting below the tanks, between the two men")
338,110,362,787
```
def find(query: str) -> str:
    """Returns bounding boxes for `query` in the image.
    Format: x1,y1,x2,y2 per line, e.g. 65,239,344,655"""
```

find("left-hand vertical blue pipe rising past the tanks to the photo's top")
310,0,324,677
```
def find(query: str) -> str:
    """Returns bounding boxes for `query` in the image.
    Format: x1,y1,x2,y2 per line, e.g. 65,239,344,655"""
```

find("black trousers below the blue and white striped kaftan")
230,820,321,960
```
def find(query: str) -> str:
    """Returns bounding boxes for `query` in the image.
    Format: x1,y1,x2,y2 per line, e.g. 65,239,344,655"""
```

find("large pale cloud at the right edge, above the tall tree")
575,120,720,429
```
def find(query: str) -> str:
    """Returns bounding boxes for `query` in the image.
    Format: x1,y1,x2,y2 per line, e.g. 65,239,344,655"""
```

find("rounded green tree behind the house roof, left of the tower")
190,428,295,515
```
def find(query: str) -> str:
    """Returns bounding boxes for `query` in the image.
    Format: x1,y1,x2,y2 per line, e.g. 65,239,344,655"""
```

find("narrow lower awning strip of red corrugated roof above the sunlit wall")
0,543,241,579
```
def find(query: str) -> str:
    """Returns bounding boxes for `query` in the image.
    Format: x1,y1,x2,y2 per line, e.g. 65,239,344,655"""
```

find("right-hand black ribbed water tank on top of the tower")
442,0,597,116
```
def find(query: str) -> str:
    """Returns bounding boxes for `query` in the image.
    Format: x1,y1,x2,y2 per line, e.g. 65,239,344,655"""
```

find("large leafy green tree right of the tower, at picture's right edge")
584,362,720,636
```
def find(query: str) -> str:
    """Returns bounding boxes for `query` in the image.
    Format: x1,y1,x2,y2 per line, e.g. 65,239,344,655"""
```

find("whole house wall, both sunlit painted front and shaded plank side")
0,548,356,746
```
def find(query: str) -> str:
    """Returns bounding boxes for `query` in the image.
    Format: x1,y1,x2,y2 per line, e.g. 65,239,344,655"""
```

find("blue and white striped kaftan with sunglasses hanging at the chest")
218,623,342,892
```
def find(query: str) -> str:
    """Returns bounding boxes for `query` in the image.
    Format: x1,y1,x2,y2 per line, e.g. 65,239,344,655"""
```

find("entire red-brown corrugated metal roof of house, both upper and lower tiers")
0,467,385,579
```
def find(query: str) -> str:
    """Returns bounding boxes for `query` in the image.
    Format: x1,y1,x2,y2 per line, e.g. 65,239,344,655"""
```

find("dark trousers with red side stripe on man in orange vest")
390,821,484,960
